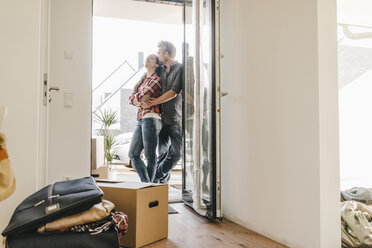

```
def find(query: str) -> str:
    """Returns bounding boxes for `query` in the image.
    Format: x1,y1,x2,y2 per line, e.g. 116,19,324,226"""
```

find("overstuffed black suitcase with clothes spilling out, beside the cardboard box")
2,177,128,248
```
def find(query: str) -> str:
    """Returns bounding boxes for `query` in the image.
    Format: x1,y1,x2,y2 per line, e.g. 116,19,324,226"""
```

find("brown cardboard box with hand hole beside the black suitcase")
97,181,168,248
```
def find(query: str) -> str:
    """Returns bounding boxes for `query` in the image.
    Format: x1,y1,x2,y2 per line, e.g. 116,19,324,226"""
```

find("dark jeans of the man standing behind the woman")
154,124,182,183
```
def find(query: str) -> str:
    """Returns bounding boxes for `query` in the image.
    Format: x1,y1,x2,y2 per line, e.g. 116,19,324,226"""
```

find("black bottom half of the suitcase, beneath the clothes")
6,228,119,248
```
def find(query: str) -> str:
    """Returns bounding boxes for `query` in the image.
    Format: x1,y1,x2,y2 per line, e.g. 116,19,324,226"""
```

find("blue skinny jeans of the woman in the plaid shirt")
128,118,162,182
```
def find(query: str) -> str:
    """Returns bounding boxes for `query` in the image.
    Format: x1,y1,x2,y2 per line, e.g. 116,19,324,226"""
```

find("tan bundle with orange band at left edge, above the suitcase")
0,133,16,201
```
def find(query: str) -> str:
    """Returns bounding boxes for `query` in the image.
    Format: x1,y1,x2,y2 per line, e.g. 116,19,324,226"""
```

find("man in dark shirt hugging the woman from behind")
143,41,183,183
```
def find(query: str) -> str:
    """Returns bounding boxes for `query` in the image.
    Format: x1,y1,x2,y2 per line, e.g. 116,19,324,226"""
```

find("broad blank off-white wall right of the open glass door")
221,0,340,248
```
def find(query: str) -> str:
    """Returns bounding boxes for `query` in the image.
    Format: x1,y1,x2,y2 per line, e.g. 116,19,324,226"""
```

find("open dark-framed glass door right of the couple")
182,0,220,218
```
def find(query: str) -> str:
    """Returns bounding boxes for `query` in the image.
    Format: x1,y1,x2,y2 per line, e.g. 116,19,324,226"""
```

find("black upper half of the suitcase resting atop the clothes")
2,177,103,237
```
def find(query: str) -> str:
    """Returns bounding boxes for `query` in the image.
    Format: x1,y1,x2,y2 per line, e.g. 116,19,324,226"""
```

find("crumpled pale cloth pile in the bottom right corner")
341,187,372,248
